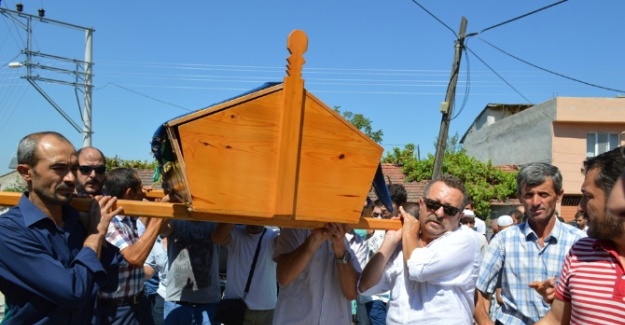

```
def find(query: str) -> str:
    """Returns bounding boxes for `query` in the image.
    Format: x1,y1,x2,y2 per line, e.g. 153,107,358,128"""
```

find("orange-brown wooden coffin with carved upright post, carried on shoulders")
153,30,383,225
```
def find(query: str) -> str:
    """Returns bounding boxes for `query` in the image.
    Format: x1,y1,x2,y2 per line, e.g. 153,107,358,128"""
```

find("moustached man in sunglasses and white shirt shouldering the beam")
358,176,481,325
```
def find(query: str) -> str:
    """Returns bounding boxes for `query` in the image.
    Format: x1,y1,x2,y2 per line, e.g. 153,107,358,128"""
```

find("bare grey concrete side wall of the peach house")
463,99,556,165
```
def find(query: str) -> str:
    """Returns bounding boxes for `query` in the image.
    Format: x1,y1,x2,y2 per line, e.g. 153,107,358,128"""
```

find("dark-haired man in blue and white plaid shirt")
475,163,585,325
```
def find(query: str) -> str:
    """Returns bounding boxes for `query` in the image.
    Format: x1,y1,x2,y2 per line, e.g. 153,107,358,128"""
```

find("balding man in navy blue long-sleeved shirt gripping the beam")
0,132,122,324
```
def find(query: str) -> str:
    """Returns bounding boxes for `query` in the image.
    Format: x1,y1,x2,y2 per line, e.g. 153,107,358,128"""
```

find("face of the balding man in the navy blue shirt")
26,135,78,205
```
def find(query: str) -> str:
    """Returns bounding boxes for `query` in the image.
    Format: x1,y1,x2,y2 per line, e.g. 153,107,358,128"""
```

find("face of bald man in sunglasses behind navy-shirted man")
78,148,106,196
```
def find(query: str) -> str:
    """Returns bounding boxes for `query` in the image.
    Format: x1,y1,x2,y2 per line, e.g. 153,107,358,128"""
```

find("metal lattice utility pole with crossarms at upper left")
0,6,95,146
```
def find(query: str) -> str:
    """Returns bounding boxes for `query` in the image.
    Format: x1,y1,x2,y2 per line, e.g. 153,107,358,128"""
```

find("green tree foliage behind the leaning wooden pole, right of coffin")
384,132,517,216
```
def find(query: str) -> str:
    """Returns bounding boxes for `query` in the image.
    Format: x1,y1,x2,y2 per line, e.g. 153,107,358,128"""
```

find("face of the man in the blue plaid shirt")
519,177,564,223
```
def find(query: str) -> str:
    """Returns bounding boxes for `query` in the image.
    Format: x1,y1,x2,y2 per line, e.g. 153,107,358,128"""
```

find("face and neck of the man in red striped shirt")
578,168,625,239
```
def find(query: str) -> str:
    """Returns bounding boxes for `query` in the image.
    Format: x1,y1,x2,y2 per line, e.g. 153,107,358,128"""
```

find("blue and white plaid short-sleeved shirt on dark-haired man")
476,220,586,325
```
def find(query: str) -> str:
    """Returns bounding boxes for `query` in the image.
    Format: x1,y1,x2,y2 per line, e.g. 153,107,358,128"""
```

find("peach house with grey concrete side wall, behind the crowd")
460,97,625,221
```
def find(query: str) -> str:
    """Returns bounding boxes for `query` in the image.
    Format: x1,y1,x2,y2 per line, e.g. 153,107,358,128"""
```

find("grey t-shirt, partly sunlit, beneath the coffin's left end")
165,220,221,304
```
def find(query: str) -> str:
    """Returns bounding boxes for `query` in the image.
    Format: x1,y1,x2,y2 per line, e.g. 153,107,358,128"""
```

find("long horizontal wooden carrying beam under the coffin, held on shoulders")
0,192,401,230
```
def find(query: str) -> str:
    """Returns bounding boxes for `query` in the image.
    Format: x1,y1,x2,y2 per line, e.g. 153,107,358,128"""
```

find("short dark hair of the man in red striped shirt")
582,147,625,200
